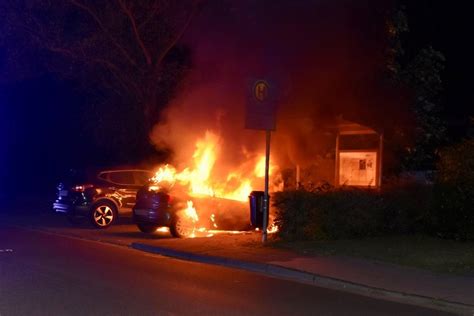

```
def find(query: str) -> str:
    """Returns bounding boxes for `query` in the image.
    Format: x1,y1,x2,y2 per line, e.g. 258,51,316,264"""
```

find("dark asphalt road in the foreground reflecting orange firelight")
0,225,452,316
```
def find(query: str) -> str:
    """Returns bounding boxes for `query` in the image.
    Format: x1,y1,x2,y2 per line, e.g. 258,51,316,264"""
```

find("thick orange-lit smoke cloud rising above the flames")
150,0,400,172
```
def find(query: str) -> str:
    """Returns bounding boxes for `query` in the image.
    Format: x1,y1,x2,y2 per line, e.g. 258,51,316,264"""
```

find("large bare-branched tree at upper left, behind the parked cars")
0,0,201,162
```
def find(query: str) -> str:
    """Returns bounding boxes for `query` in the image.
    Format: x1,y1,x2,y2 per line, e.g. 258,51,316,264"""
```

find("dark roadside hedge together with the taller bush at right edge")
273,138,474,241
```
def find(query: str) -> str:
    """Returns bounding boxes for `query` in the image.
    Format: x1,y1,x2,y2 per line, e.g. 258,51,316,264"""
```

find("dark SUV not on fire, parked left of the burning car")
53,169,153,228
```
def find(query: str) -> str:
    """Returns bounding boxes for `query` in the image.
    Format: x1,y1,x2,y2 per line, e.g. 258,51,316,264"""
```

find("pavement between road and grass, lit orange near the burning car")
131,233,474,316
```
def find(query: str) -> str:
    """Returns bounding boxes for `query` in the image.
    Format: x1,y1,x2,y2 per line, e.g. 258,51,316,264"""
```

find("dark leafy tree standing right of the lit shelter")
386,7,446,170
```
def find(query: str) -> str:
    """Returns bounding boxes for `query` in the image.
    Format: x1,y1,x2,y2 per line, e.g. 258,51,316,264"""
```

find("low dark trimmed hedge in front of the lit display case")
274,183,432,240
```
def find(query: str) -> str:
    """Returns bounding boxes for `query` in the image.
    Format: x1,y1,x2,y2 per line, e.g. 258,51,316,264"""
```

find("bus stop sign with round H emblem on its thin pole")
245,80,277,243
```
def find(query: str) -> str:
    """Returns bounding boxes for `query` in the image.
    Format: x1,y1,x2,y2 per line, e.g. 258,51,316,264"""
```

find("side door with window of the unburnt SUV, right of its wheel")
108,170,140,213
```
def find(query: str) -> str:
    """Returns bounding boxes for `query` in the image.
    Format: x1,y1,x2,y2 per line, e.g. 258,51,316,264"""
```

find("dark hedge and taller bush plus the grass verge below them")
273,138,474,274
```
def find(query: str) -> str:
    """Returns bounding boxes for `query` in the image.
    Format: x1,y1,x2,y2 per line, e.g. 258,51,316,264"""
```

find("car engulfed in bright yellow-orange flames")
133,131,282,237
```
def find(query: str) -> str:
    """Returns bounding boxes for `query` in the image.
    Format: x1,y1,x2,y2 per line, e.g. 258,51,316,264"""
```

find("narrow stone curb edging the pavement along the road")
130,242,474,316
